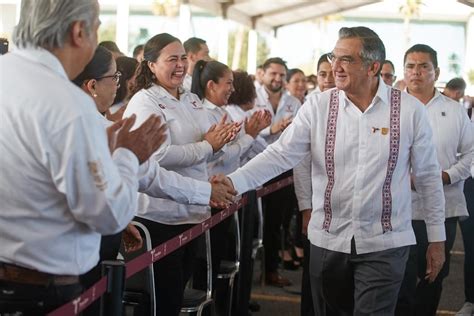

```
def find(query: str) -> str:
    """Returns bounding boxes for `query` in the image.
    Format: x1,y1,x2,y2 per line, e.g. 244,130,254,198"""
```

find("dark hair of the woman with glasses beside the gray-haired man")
72,46,114,87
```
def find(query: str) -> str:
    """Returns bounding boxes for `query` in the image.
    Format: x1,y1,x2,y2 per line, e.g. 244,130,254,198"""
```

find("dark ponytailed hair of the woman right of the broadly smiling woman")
191,60,230,100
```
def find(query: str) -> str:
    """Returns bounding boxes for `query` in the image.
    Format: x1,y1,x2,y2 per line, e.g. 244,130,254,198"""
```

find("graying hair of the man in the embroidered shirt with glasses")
339,26,385,75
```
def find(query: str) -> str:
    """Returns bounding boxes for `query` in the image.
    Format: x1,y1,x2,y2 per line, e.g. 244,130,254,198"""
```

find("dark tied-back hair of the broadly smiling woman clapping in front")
132,33,181,95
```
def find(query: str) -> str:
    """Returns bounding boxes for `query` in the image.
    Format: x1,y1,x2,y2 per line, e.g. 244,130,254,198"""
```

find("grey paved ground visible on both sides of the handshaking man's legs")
248,223,464,316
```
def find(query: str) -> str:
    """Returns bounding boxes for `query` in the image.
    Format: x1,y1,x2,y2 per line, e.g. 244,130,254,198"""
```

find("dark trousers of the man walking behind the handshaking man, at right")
396,217,458,316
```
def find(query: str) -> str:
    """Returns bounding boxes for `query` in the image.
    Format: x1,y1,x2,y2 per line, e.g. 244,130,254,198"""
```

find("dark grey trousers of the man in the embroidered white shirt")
310,240,409,316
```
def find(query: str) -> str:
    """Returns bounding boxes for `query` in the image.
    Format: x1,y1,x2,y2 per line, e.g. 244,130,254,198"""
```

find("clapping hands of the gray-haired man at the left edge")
115,114,166,164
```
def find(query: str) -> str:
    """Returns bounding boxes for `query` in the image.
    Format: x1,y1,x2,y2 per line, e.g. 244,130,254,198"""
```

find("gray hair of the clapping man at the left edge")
12,0,99,49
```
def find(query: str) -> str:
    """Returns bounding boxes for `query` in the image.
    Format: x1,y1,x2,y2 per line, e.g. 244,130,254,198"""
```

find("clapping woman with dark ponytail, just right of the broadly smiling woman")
191,60,271,312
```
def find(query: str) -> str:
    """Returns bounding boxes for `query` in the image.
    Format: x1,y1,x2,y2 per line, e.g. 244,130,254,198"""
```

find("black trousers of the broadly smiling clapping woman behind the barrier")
135,217,197,316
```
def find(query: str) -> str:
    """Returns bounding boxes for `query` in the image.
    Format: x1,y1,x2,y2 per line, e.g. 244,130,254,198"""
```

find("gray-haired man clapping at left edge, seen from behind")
0,0,164,315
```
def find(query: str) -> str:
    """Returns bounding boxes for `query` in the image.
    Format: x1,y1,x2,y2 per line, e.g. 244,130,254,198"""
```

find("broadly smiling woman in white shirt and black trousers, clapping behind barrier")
124,33,235,316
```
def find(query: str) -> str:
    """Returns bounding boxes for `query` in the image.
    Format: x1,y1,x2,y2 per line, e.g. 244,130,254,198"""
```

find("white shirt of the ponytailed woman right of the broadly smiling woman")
203,99,254,176
